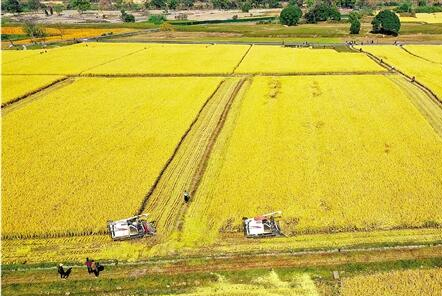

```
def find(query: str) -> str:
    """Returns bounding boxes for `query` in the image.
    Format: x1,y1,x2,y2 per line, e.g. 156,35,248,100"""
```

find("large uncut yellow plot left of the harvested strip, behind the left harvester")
2,77,221,237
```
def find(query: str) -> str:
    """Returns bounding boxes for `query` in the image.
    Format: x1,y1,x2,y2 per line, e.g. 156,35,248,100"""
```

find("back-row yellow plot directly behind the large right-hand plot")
235,46,385,73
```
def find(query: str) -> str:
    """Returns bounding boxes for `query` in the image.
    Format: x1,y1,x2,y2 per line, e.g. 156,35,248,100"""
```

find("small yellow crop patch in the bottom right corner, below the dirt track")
341,268,442,296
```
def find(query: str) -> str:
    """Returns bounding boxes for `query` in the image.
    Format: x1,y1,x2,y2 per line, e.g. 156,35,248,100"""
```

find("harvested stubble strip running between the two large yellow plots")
139,78,244,240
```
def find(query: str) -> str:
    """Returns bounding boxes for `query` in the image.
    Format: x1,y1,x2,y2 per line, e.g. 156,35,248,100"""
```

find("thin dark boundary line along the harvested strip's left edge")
136,79,225,215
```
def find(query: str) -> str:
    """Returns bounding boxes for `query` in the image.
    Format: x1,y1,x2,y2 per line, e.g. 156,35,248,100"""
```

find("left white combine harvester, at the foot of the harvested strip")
107,214,156,240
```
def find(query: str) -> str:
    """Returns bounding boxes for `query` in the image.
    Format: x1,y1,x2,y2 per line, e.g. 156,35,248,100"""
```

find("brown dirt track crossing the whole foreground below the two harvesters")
2,246,442,285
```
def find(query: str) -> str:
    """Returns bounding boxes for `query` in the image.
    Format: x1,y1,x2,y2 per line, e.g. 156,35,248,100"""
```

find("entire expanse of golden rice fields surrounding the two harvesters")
2,43,442,262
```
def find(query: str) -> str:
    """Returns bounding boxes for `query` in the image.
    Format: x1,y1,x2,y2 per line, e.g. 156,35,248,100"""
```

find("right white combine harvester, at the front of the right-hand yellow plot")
243,211,284,238
